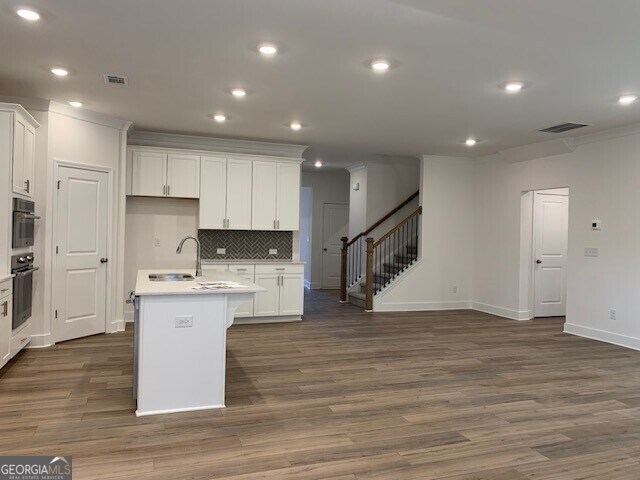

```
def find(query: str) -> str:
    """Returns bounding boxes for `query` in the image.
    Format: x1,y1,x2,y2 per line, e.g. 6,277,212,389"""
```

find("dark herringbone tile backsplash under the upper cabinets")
198,230,293,260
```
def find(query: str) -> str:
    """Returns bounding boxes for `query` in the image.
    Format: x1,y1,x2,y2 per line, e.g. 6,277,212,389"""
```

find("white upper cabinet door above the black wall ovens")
12,113,36,197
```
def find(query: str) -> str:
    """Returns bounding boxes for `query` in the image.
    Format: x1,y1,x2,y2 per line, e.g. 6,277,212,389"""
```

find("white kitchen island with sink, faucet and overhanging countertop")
134,269,265,416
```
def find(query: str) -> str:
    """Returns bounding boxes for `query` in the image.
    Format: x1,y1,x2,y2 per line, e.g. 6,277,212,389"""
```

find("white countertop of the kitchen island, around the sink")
136,268,266,296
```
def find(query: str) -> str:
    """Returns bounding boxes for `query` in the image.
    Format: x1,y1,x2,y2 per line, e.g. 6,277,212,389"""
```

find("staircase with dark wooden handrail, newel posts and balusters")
340,192,422,311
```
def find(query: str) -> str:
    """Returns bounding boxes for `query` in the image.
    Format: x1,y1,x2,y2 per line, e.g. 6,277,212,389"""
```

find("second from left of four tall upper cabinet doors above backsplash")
227,159,253,230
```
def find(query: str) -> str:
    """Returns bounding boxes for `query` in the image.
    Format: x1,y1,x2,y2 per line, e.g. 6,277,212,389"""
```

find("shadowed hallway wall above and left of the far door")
302,170,350,288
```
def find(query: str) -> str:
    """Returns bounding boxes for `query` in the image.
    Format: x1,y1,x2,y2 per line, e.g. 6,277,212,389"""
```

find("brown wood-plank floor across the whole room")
0,286,640,480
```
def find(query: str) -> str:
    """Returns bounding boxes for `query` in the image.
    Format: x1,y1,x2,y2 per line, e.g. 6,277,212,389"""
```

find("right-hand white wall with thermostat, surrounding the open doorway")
473,134,640,349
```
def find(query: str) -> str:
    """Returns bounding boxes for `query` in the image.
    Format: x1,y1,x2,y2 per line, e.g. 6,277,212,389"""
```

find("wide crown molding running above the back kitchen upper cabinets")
128,131,307,159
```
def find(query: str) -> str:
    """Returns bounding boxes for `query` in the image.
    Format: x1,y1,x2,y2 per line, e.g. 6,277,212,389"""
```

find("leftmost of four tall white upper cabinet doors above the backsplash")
199,157,227,230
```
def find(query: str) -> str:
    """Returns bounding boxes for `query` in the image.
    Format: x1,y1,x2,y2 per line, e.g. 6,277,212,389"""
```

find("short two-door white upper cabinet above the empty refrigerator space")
131,151,200,198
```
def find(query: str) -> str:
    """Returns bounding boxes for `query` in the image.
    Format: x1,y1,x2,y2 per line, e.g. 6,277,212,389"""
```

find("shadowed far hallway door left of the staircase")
322,203,349,288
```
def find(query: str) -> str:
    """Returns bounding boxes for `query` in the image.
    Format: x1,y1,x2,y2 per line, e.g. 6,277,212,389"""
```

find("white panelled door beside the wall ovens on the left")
53,166,109,342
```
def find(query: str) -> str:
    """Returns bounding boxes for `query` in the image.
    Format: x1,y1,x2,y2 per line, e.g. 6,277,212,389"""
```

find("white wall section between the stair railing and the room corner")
374,156,474,311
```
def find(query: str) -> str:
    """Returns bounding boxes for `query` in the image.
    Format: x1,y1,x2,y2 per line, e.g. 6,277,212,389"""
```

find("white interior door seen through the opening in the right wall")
533,192,569,317
